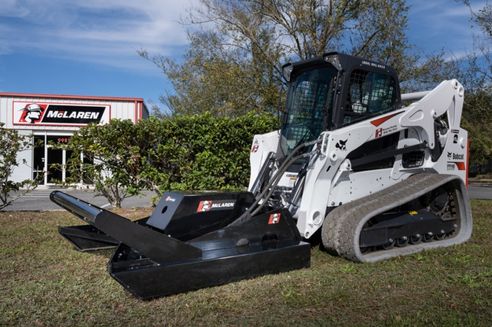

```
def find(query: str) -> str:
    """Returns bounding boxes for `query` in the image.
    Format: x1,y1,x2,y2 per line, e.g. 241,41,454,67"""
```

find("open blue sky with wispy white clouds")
0,0,486,113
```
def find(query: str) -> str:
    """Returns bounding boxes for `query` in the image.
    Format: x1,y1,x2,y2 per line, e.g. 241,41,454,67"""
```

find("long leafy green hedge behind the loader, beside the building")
69,113,278,202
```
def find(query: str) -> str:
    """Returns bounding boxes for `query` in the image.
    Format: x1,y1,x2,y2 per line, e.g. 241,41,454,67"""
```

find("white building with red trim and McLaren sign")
0,92,149,187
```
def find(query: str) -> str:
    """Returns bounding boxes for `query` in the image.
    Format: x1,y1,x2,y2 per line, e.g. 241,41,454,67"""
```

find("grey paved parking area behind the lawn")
3,185,492,211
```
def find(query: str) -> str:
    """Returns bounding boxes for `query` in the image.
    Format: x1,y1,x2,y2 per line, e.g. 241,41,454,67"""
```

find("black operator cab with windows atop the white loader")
278,52,401,158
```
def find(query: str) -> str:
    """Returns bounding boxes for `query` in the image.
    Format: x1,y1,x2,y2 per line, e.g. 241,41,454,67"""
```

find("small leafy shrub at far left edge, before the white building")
0,123,37,210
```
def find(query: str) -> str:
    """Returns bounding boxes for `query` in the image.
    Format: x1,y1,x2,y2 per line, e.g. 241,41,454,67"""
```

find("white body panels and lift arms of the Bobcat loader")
249,80,469,238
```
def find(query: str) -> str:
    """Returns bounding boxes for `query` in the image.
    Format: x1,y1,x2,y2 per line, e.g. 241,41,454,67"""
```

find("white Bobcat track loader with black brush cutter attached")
51,52,472,299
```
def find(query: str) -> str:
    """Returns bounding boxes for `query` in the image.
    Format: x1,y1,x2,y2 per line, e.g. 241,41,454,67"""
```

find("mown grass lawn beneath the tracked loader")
0,201,492,326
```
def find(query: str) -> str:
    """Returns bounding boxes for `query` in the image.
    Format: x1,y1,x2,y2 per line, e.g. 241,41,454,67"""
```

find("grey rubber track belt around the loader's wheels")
321,173,472,262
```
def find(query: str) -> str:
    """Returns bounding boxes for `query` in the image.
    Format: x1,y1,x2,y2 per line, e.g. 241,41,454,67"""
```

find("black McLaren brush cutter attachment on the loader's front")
50,191,310,299
